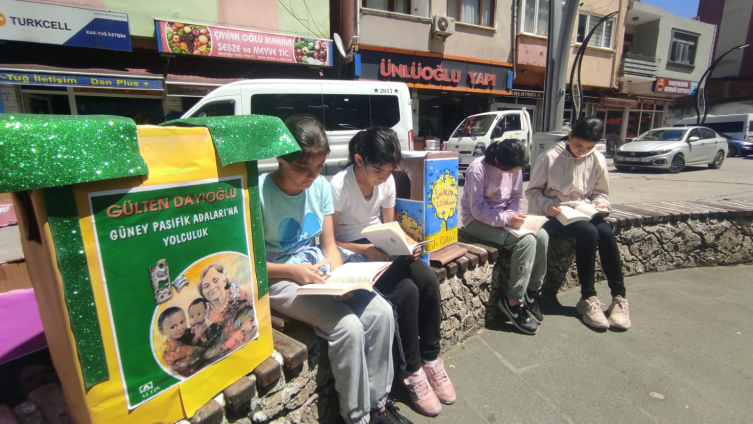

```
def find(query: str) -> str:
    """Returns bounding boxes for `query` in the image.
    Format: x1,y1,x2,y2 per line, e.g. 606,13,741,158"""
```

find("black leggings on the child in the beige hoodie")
544,216,625,299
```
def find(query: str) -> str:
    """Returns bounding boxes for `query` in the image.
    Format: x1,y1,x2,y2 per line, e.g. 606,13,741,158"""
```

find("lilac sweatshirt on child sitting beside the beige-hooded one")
460,156,523,227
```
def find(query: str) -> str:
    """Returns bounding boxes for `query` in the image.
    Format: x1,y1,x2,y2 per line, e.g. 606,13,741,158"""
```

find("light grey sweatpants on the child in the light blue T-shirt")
269,280,395,423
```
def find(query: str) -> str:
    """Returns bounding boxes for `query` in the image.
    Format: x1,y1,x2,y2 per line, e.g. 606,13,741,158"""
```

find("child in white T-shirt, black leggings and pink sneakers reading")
332,127,457,416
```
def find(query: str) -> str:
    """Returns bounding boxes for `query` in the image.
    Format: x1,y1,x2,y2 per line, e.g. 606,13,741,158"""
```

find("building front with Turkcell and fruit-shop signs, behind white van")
0,0,332,124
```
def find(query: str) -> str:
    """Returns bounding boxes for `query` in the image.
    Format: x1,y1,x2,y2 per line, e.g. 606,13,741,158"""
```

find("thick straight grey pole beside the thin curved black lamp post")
543,0,580,132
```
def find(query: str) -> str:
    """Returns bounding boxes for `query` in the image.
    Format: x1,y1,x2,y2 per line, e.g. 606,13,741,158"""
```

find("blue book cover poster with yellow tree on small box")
424,158,458,252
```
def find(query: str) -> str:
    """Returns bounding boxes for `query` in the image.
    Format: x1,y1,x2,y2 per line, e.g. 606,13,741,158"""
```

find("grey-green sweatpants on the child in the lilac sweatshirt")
465,220,549,302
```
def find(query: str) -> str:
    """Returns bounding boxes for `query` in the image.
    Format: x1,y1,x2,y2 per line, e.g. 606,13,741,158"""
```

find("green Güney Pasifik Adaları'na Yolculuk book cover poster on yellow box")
89,176,258,409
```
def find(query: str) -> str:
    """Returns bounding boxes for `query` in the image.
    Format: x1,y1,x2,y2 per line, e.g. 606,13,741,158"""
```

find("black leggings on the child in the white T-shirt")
374,256,441,374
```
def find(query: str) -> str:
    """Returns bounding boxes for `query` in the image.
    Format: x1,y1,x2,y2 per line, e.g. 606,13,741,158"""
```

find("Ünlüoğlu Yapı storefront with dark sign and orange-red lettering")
347,45,516,140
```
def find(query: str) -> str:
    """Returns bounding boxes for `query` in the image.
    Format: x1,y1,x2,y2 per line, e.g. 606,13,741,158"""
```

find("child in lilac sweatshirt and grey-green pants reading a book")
461,139,549,335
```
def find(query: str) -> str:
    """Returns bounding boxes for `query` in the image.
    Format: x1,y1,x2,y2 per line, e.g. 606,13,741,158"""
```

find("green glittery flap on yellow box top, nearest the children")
160,115,301,166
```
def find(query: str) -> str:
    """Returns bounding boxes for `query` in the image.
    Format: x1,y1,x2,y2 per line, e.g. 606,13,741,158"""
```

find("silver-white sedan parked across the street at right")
614,127,728,173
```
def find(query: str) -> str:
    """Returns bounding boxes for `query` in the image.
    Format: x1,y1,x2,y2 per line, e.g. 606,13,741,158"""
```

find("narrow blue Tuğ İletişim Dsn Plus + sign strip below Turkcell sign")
0,72,163,90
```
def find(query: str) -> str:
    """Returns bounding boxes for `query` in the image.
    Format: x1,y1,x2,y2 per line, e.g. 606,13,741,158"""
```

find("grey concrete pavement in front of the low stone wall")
393,266,753,423
